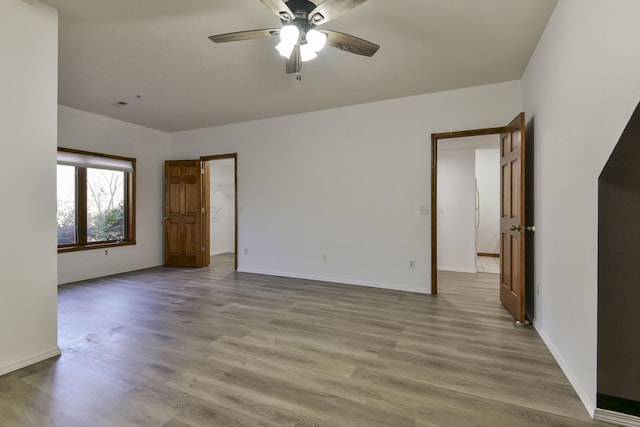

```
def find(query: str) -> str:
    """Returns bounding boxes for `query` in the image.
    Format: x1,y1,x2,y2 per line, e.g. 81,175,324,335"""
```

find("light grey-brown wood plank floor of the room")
0,256,601,427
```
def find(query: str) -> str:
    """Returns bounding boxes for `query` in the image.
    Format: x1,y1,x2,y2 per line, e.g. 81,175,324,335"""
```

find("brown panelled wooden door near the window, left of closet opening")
164,160,209,267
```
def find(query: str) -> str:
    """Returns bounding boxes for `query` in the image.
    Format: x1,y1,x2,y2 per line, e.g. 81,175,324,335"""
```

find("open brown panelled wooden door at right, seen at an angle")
500,113,526,324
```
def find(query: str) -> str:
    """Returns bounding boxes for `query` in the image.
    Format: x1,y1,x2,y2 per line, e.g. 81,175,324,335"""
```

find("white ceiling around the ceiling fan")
42,0,557,132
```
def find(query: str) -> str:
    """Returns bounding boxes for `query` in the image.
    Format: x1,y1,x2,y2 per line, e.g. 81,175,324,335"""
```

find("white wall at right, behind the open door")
523,0,640,412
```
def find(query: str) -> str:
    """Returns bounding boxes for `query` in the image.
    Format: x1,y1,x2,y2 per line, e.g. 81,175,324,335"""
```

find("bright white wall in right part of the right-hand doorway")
476,148,500,254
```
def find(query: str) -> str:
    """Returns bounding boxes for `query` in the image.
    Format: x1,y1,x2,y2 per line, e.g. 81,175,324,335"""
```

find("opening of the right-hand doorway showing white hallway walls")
434,135,500,281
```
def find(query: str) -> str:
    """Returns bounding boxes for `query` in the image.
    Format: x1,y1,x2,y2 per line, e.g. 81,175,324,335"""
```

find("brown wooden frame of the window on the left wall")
56,147,136,253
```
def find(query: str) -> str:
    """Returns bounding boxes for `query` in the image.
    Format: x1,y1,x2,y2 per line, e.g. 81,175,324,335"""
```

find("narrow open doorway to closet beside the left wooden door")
201,154,238,270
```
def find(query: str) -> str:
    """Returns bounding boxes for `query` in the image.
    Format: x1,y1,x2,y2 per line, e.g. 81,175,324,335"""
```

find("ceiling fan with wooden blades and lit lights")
209,0,380,80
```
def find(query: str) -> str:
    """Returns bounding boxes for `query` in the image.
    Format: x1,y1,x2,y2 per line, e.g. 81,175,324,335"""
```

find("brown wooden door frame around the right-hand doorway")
431,126,504,295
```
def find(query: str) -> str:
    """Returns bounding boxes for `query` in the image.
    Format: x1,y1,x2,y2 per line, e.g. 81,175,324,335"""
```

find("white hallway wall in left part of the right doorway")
438,149,476,273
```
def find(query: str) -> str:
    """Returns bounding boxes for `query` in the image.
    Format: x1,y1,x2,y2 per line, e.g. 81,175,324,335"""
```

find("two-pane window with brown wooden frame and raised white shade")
57,148,136,252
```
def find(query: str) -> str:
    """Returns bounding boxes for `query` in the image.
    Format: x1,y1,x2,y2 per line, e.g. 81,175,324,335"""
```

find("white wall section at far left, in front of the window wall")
0,0,60,375
